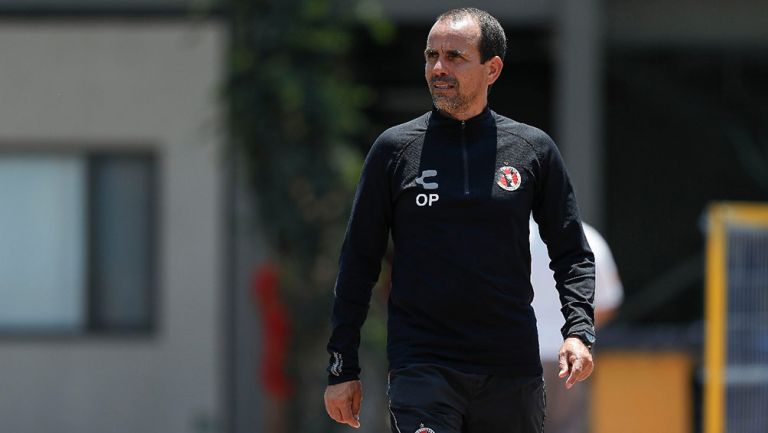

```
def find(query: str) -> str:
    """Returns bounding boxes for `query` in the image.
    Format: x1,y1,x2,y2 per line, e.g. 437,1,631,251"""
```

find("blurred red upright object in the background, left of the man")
251,262,291,399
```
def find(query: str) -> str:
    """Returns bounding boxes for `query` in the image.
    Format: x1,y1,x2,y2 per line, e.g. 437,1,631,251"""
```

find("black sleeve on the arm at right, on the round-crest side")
532,132,595,339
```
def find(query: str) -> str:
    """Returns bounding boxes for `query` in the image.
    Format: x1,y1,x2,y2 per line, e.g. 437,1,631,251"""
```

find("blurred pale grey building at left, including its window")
0,1,226,433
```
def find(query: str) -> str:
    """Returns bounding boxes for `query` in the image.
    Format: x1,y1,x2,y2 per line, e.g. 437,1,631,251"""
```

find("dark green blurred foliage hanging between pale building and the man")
227,0,393,431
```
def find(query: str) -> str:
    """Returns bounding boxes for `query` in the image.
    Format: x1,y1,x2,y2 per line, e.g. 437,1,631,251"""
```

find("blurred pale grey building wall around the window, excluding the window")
0,20,224,433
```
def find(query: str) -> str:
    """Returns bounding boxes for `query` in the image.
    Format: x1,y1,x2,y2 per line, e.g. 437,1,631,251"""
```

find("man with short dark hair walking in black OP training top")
325,8,594,433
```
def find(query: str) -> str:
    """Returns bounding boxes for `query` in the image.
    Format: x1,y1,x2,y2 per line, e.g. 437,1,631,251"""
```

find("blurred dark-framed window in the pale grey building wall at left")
0,152,156,334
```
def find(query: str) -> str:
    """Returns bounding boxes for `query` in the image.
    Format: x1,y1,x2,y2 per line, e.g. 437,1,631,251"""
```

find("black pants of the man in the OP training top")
387,365,546,433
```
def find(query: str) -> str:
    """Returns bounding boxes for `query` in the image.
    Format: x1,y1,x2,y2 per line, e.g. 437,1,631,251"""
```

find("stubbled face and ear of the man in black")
424,17,501,120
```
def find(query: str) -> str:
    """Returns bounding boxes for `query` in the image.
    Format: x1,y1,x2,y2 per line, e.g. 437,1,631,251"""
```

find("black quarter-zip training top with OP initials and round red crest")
328,108,595,384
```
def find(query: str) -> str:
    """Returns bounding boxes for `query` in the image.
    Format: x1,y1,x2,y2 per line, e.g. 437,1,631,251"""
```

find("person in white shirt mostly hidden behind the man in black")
530,218,624,433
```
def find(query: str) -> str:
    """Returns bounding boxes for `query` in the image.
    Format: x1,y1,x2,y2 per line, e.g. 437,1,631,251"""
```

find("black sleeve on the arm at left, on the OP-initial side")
327,134,393,385
